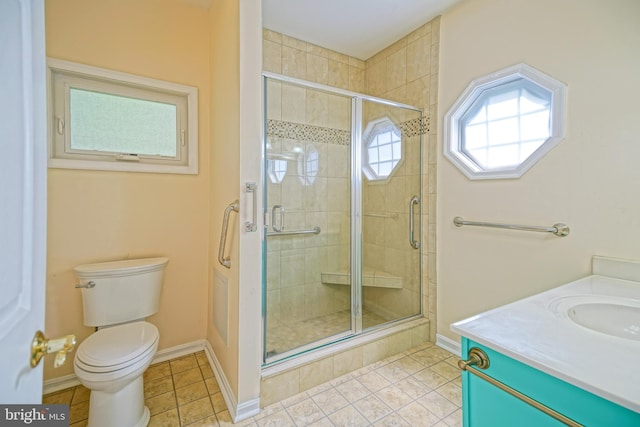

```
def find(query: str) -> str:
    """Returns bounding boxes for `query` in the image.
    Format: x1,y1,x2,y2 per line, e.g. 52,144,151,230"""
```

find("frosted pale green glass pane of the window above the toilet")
69,88,178,157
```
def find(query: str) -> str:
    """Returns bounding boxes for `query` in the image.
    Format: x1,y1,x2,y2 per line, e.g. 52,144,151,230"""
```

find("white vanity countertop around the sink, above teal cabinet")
451,257,640,412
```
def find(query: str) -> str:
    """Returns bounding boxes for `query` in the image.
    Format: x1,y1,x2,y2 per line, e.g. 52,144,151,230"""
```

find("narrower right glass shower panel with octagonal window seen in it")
361,101,422,329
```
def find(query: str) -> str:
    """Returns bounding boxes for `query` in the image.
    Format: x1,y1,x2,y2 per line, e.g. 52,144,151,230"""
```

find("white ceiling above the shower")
262,0,461,60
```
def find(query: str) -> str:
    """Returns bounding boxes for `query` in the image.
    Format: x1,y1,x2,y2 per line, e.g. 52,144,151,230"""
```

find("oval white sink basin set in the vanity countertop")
550,295,640,341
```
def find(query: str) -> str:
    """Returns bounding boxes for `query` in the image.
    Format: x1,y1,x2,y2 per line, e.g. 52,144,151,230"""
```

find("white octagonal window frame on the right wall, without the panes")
443,64,566,180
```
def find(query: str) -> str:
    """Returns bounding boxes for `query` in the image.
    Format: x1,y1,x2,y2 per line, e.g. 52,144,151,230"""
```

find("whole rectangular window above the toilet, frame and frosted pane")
48,59,198,174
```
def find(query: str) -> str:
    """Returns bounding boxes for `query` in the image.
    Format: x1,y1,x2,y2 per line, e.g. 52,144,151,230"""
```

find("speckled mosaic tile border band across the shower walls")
267,117,429,145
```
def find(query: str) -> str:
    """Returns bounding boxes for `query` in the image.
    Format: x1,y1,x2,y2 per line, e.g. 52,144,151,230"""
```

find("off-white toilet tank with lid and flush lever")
73,257,169,326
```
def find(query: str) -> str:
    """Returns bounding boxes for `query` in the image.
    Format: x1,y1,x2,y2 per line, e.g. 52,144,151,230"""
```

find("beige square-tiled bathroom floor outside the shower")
44,343,462,427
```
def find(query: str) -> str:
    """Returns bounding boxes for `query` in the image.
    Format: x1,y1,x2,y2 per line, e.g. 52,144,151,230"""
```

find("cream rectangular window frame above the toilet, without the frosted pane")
47,58,198,175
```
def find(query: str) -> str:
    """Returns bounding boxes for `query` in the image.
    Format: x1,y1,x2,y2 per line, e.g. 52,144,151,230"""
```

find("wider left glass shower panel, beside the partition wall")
263,78,352,363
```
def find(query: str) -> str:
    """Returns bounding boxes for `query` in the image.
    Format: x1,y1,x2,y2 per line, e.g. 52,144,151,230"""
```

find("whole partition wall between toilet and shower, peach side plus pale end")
207,0,262,410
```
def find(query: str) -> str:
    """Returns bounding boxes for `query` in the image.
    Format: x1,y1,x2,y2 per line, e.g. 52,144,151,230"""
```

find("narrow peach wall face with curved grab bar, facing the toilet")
207,1,240,402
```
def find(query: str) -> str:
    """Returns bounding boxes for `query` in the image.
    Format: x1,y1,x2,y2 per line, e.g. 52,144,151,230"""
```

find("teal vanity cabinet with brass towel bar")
459,337,640,427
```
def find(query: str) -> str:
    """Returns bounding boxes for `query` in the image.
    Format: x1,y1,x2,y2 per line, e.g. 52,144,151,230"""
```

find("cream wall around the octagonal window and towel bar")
438,0,640,339
